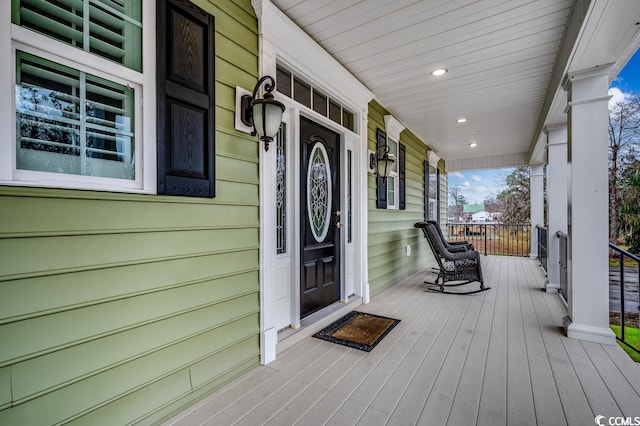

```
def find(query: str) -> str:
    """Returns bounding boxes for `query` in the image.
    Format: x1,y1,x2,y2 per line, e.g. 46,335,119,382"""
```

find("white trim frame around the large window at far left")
0,1,157,193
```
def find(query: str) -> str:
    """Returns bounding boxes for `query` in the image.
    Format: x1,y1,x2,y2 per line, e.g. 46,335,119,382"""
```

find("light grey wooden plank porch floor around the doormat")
169,256,640,426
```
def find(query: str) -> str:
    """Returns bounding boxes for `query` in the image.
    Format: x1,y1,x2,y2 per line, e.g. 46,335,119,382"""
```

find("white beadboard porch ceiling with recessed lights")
272,0,640,168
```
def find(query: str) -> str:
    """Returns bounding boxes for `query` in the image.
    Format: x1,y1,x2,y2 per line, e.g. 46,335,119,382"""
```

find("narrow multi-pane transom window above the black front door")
276,65,356,132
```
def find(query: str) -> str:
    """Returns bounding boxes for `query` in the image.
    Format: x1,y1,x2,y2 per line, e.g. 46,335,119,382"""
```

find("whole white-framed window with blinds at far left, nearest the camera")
0,0,156,192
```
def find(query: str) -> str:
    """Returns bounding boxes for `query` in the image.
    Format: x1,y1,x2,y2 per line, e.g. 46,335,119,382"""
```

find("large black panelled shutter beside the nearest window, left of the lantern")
156,0,215,197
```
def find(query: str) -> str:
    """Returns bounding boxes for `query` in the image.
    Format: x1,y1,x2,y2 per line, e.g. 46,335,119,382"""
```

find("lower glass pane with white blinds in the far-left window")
16,51,135,180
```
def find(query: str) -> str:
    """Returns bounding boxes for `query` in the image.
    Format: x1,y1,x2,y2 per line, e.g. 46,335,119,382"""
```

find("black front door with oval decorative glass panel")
300,117,341,318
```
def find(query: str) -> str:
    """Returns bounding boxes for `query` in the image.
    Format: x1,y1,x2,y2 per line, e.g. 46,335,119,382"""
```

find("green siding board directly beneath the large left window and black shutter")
0,192,260,238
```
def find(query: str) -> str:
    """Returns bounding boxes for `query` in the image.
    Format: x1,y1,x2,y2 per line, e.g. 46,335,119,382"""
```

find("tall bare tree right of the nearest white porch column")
608,93,640,244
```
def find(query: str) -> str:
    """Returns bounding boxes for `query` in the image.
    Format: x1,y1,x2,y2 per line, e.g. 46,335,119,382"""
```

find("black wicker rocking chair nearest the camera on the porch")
413,222,491,294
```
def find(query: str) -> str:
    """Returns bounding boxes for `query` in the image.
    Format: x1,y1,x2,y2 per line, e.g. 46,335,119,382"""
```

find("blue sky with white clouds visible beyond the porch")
448,50,640,204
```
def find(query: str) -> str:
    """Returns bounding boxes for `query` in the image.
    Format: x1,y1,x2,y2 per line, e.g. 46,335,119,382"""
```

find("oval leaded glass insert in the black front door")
307,142,331,242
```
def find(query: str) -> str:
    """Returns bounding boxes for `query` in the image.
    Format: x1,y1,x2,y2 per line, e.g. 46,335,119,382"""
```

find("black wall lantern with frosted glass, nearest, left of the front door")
240,75,285,151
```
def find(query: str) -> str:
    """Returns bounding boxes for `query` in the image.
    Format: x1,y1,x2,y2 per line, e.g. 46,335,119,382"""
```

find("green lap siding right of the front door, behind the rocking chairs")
368,101,434,296
